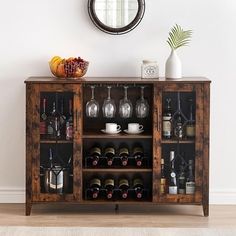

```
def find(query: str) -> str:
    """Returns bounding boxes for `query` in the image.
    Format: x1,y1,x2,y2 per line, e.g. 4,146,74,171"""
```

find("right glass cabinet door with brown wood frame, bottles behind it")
154,85,203,203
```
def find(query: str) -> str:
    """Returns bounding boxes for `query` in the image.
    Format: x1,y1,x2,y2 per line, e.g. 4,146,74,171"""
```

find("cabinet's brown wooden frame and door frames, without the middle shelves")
25,77,210,216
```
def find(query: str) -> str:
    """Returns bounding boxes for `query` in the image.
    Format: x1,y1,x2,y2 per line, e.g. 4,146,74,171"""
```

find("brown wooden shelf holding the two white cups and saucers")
82,132,152,139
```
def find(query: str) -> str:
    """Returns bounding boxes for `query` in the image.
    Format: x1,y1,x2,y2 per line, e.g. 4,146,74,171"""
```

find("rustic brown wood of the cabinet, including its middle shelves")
25,77,210,216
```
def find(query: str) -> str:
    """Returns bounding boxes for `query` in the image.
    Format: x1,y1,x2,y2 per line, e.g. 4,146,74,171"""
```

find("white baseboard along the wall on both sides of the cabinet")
0,188,236,205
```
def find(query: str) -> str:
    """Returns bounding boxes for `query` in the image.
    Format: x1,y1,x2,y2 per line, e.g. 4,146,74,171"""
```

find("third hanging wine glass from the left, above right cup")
119,86,133,118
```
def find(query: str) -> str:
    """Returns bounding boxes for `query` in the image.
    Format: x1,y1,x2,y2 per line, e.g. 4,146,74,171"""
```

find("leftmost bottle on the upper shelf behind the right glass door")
162,98,172,139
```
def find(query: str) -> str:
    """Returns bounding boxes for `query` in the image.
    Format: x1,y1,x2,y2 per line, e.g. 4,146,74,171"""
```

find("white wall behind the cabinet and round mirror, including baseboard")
0,0,236,203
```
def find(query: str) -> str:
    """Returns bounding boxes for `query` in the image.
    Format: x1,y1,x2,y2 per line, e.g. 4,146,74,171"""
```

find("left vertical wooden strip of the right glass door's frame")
152,85,162,202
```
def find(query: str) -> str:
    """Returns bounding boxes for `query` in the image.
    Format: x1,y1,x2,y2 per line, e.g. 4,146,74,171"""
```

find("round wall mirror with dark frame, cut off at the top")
88,0,145,34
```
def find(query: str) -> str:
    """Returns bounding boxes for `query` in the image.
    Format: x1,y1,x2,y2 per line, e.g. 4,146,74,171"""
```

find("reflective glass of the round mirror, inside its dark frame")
94,0,139,28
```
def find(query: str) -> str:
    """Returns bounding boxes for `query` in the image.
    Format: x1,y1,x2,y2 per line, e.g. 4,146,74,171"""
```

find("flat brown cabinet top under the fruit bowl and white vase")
25,77,211,84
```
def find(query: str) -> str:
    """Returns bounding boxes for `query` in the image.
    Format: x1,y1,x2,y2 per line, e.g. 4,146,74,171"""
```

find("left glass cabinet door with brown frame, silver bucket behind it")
30,84,81,201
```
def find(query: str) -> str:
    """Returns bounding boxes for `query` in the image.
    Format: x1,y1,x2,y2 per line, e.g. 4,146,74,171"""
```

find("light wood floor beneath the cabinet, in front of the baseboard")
0,204,236,228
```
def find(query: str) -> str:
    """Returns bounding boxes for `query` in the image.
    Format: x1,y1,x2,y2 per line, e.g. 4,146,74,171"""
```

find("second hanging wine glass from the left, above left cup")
102,86,116,118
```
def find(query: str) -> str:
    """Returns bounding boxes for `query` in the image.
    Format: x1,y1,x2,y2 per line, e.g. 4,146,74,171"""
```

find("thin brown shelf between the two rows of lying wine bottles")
83,168,152,173
